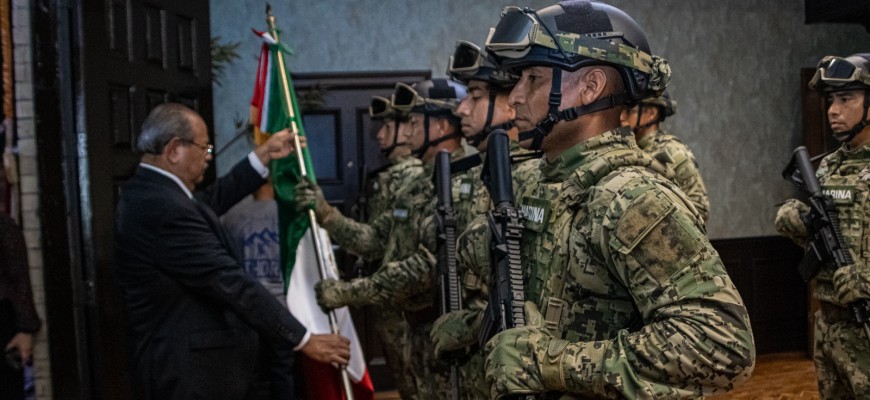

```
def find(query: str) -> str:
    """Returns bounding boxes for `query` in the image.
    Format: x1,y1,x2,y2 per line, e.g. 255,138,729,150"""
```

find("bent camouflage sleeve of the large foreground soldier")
557,181,755,398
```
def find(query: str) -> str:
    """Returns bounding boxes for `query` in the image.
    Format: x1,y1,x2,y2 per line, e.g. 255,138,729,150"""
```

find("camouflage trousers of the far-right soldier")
813,307,870,400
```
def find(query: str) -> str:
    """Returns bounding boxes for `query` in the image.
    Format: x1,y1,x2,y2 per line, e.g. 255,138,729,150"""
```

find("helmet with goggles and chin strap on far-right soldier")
808,53,870,142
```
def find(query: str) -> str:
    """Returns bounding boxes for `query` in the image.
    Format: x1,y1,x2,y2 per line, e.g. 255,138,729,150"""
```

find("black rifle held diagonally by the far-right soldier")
782,146,870,340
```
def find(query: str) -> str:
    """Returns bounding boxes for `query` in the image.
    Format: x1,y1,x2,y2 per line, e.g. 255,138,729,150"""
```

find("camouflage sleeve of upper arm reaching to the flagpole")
321,211,393,260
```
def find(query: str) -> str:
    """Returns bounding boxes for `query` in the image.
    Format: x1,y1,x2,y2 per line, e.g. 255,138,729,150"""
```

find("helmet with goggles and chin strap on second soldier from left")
392,78,466,157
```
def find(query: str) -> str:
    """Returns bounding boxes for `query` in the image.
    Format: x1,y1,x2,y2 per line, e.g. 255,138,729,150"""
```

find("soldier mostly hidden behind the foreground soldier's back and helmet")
620,92,710,223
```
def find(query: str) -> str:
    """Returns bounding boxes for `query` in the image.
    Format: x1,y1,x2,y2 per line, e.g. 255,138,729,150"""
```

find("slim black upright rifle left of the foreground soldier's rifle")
433,150,462,400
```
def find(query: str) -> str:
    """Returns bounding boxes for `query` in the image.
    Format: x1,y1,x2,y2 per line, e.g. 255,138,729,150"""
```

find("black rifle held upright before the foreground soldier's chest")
478,129,526,346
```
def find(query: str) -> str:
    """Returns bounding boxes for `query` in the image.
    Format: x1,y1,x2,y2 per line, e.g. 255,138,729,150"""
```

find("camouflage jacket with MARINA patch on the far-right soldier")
814,144,870,304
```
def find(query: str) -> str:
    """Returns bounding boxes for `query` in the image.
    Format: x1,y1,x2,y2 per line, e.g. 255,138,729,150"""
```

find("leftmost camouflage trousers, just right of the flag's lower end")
372,307,418,400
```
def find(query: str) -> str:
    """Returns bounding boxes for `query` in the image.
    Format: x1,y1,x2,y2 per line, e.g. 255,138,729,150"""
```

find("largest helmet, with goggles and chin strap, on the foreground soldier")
486,0,670,148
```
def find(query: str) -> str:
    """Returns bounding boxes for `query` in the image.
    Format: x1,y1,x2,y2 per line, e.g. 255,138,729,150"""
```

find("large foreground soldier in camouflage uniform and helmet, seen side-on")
470,1,755,399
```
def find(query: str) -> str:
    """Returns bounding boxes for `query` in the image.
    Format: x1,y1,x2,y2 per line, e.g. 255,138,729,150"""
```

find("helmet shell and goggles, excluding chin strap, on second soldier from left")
392,78,466,116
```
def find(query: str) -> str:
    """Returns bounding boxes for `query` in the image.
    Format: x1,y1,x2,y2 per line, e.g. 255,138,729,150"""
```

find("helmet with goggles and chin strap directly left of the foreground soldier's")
447,40,519,147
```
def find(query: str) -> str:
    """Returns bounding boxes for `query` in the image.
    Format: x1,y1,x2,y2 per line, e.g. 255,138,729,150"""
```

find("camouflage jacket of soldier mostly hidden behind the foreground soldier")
637,129,710,223
